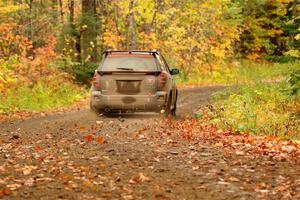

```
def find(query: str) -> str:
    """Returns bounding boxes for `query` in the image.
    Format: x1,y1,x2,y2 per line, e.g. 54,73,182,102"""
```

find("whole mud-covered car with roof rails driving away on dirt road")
90,50,179,115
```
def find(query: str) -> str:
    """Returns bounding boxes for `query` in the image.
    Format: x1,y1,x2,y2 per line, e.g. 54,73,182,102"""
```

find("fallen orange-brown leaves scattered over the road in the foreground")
0,97,300,199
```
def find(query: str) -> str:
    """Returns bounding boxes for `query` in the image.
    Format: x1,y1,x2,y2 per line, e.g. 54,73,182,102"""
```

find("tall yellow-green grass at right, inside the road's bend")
214,82,300,140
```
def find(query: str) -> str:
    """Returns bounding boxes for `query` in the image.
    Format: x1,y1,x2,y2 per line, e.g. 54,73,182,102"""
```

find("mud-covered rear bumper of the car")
91,91,167,112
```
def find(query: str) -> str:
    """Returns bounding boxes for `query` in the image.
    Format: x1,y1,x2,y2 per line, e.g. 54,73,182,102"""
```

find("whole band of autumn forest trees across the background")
0,0,300,83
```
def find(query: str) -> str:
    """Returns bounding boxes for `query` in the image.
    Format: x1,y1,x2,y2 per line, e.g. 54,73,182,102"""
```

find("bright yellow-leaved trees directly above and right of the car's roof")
98,0,241,74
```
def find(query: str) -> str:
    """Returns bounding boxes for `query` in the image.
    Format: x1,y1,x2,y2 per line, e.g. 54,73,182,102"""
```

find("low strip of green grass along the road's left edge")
0,80,86,113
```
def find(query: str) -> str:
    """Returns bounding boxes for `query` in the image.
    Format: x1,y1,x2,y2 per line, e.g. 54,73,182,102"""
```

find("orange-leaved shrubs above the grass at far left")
0,23,73,93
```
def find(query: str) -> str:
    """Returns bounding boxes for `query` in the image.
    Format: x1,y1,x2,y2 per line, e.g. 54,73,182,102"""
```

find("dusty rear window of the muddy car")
101,55,158,71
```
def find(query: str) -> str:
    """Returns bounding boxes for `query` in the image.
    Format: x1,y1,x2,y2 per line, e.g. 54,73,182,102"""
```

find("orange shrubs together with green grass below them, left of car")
0,6,80,113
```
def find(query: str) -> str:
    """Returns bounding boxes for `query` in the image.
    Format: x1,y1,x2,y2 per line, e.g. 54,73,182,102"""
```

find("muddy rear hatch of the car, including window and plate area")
98,53,160,95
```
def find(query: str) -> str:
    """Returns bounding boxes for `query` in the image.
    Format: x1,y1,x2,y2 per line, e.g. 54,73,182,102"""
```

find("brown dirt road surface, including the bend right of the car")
0,87,300,200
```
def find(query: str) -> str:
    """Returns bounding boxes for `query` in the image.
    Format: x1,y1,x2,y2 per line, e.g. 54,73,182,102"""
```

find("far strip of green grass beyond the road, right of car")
176,60,300,85
